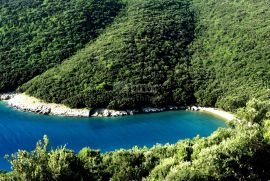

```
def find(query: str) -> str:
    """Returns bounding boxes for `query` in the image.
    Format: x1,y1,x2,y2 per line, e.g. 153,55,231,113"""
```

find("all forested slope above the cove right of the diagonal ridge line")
19,0,270,111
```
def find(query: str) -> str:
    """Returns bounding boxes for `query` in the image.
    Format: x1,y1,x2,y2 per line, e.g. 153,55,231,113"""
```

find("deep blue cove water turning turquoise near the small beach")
0,102,226,170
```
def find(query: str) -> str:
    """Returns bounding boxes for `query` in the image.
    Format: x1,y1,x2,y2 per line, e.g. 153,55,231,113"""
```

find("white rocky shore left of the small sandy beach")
0,94,183,117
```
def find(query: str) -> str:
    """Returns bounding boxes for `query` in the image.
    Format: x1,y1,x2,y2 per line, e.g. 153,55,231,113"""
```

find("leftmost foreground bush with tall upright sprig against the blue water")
5,136,83,180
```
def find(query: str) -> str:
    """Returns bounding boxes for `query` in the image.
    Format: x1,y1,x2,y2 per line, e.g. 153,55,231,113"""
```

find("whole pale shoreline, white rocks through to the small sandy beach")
0,93,236,122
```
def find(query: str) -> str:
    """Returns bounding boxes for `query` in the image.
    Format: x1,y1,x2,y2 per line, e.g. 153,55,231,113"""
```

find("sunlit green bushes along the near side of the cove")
1,99,270,181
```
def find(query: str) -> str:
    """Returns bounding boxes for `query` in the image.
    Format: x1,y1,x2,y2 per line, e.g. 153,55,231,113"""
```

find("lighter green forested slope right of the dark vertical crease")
190,0,270,111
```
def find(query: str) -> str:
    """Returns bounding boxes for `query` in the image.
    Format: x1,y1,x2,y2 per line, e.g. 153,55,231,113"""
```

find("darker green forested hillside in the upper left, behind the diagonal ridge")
0,0,122,92
